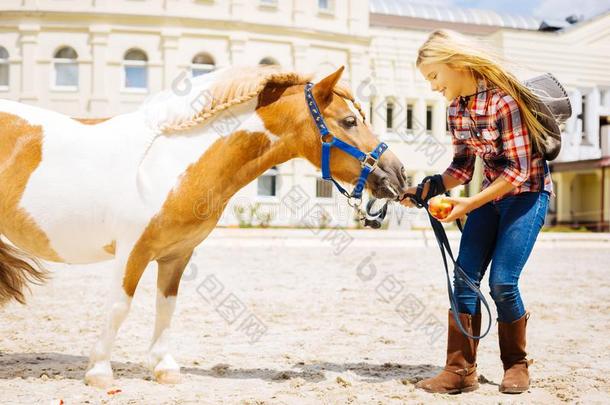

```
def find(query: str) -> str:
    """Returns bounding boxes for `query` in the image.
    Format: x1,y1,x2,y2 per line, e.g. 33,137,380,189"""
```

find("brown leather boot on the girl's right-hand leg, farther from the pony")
498,313,533,394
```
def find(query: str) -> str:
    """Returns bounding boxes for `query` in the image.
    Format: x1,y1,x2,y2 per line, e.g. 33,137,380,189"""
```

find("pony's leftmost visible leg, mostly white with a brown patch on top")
85,241,150,388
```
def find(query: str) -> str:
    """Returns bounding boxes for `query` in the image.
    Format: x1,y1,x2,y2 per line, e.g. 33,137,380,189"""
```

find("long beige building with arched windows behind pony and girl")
0,0,610,227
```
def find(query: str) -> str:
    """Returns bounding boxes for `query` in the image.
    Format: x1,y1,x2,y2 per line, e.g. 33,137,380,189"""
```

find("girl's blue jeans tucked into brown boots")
453,192,549,322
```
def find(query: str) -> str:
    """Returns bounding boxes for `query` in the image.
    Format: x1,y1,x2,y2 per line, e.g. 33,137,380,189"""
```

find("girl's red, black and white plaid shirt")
445,81,553,200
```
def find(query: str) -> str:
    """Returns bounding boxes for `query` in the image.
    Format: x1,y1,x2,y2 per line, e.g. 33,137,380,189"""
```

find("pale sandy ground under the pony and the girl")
0,230,610,404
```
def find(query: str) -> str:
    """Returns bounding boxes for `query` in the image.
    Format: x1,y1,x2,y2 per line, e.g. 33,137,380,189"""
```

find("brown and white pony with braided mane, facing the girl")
0,67,405,387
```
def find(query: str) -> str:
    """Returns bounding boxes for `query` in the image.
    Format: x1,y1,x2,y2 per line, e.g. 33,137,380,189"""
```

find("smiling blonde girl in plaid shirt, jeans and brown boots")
403,30,552,393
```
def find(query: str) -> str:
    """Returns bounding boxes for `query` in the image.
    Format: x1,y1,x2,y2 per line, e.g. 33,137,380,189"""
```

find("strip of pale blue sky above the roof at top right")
422,0,610,20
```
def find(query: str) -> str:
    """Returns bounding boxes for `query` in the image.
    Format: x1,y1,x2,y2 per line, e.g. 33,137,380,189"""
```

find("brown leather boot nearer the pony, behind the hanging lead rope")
415,311,481,394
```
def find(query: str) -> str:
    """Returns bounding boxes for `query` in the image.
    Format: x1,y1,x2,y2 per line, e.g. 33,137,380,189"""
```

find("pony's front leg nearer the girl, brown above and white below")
148,251,193,384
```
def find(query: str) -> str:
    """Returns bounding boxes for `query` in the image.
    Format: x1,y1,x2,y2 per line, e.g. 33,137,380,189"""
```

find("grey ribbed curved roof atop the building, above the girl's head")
369,0,542,30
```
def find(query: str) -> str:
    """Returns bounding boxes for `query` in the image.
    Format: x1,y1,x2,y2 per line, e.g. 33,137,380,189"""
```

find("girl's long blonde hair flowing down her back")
416,30,546,150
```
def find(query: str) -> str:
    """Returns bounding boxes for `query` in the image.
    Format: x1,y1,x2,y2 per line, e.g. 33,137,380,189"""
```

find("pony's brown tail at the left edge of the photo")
0,235,49,307
